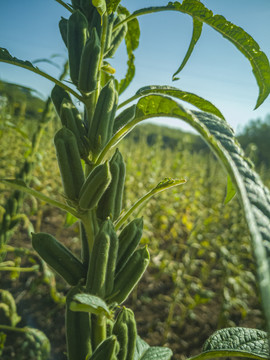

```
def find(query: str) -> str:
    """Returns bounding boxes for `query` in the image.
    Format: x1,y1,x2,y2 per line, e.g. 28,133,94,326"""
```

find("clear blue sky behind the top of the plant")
0,0,270,134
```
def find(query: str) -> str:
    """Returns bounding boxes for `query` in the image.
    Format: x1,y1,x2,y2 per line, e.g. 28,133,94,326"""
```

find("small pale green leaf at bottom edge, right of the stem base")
133,336,173,360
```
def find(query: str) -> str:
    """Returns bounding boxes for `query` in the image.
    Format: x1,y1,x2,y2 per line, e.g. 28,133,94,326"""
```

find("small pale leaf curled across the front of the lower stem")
69,294,111,318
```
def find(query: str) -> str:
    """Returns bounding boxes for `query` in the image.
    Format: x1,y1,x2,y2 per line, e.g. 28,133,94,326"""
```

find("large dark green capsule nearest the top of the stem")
67,10,88,85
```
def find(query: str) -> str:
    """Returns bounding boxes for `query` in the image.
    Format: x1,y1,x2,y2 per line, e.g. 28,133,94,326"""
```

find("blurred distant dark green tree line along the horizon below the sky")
0,81,270,168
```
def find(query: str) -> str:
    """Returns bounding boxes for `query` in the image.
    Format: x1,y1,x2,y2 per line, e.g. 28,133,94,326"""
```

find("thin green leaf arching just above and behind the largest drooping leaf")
118,85,224,119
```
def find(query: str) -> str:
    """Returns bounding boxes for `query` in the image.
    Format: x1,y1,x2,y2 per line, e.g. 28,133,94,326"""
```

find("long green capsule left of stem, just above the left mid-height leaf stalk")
54,127,84,201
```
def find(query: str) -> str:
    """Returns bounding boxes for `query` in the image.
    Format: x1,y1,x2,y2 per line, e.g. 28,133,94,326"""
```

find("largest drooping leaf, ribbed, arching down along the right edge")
104,95,270,329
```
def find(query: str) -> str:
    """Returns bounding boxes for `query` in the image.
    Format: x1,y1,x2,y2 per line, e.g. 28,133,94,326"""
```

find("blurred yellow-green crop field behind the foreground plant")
0,99,267,360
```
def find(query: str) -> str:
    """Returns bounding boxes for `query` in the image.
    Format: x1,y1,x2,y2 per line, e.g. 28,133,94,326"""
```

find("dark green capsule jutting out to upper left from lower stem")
32,233,86,285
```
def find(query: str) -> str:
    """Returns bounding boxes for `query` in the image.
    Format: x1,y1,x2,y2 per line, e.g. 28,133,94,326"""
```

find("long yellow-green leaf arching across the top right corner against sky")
124,0,270,109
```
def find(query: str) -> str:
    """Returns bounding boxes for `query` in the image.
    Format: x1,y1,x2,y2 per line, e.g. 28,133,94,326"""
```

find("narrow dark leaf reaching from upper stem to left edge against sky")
0,47,83,101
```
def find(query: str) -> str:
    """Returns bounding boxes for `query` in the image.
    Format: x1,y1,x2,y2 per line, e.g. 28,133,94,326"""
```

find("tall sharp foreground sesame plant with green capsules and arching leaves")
0,0,270,360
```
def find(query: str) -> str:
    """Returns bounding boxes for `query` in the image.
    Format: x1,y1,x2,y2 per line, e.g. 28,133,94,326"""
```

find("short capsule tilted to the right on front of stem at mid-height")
79,161,112,210
